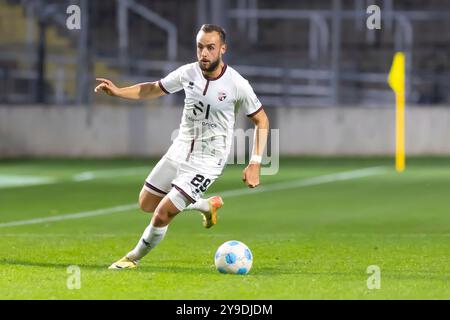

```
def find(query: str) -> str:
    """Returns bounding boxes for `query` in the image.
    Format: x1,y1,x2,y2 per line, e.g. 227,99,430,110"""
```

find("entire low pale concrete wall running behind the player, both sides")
0,106,450,157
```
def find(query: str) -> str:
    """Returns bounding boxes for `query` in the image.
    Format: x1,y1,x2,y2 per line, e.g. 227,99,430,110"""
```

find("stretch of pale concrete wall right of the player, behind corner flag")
275,107,450,155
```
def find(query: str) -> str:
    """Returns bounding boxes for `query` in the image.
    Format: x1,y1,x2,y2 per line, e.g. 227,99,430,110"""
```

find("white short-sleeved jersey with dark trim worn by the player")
158,62,262,174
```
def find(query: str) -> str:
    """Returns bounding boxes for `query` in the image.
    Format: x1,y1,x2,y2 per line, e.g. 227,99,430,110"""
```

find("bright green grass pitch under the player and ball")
0,158,450,300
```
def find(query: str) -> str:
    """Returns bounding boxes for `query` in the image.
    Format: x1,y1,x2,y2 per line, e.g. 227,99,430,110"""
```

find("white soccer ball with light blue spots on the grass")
214,240,253,274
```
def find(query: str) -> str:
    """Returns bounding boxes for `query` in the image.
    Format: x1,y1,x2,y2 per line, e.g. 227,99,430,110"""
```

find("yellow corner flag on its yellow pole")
388,52,405,172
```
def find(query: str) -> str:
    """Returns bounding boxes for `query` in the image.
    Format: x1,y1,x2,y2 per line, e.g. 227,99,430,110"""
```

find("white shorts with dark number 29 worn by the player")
144,156,218,211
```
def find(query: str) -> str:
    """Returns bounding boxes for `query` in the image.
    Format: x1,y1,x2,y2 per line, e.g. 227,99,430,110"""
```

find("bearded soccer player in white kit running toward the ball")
95,24,269,269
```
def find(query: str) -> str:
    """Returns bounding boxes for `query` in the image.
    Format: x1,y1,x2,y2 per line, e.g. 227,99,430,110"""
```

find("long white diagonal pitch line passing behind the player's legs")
0,167,387,228
